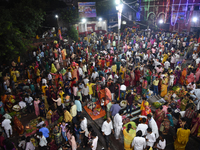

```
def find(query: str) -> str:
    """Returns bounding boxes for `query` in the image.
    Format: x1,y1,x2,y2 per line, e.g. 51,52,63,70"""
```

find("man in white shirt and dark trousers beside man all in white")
101,117,114,150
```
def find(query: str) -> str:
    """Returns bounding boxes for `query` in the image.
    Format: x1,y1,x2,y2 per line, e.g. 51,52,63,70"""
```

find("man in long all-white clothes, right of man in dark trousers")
113,110,123,140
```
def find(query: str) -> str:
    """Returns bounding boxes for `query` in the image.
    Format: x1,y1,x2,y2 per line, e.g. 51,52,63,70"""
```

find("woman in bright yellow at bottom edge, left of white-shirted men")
123,123,136,150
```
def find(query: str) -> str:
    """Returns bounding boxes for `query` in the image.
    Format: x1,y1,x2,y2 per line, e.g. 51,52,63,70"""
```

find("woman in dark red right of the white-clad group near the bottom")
154,106,165,129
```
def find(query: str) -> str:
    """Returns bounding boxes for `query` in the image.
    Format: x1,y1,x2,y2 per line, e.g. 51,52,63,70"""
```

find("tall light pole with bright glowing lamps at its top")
115,0,123,51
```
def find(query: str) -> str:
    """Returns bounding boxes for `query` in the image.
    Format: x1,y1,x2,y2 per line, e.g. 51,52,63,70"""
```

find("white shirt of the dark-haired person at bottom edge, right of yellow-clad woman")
131,137,146,150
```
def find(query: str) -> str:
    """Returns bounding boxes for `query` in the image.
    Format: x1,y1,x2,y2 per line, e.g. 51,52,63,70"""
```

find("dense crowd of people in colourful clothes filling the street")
0,28,200,150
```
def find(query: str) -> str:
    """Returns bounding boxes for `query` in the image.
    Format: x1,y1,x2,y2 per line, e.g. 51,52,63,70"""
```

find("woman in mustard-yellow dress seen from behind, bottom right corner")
174,124,190,150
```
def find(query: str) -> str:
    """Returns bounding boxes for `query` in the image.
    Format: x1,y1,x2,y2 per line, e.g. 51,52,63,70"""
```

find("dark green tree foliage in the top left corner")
0,0,45,64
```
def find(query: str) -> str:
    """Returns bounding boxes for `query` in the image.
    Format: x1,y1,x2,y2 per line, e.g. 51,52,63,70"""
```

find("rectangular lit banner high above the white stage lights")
78,2,97,18
